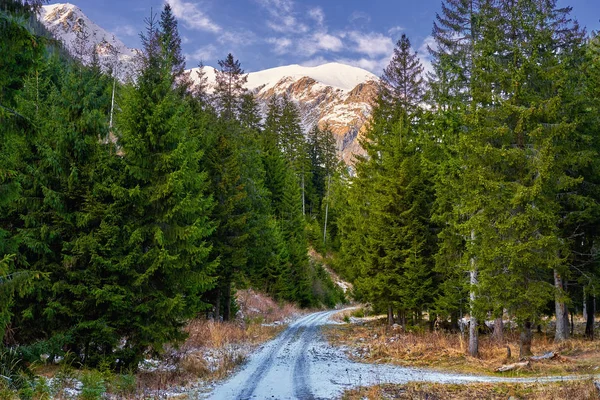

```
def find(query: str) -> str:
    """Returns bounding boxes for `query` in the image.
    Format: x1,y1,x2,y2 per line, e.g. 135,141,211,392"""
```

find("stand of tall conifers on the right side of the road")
338,0,600,357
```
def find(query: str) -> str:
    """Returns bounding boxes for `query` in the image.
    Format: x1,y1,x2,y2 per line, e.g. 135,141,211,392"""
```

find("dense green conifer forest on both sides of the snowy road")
0,0,600,396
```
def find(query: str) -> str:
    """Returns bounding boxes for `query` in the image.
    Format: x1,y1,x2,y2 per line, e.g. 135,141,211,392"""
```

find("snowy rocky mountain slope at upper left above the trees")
39,3,138,78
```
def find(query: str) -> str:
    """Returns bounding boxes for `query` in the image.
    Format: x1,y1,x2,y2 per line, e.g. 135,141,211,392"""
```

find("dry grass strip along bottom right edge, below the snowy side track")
342,380,598,400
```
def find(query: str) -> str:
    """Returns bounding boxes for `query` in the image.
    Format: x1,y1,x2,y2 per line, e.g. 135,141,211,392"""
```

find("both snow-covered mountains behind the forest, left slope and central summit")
39,3,378,164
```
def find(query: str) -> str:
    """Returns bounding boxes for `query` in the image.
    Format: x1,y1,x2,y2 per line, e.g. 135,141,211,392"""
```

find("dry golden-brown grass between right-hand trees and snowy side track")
326,311,600,376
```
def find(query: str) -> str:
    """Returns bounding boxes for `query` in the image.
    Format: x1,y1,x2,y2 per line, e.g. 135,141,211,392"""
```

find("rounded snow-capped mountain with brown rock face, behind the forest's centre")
190,63,378,164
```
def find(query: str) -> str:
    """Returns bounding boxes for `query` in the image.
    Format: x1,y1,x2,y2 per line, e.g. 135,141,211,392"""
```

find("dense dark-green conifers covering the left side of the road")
0,1,343,376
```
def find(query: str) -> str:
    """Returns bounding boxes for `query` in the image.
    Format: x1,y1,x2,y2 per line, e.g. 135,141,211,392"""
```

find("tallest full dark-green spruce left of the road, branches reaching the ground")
113,17,215,361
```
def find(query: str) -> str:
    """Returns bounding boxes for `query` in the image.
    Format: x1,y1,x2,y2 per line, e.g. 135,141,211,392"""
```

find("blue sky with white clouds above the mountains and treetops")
71,0,600,75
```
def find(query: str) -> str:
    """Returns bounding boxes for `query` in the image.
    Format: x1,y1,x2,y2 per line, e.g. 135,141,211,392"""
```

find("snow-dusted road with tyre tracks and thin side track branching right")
208,311,592,400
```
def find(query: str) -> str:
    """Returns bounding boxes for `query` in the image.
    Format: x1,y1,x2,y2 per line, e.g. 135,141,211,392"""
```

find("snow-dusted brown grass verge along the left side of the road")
0,290,305,400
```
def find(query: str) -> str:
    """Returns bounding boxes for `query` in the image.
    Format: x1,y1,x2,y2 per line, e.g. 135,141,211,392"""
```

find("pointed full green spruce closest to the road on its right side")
342,37,434,325
